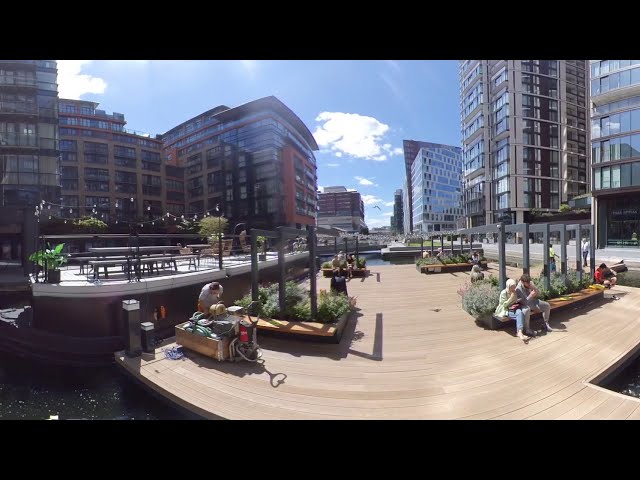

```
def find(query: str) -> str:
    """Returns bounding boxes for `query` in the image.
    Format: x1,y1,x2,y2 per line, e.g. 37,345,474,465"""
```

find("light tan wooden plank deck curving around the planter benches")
116,265,640,419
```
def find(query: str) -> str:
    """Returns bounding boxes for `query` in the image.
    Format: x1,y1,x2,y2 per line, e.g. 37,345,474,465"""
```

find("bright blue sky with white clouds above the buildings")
58,60,460,227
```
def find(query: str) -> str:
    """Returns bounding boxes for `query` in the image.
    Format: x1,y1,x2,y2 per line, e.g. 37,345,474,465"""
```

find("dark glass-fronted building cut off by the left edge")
0,60,60,268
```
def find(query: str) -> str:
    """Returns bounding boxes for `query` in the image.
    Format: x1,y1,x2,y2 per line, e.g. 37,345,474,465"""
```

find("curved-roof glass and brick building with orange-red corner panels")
162,96,318,229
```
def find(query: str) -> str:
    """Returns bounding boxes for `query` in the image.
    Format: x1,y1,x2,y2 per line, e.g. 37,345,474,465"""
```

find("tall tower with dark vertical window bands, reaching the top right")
459,60,589,226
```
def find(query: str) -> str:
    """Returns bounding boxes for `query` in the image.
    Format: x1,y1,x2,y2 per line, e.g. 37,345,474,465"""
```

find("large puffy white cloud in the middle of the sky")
313,112,402,162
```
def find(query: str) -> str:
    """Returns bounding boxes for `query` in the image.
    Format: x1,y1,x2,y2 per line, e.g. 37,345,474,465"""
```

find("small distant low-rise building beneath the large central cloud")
318,187,367,233
